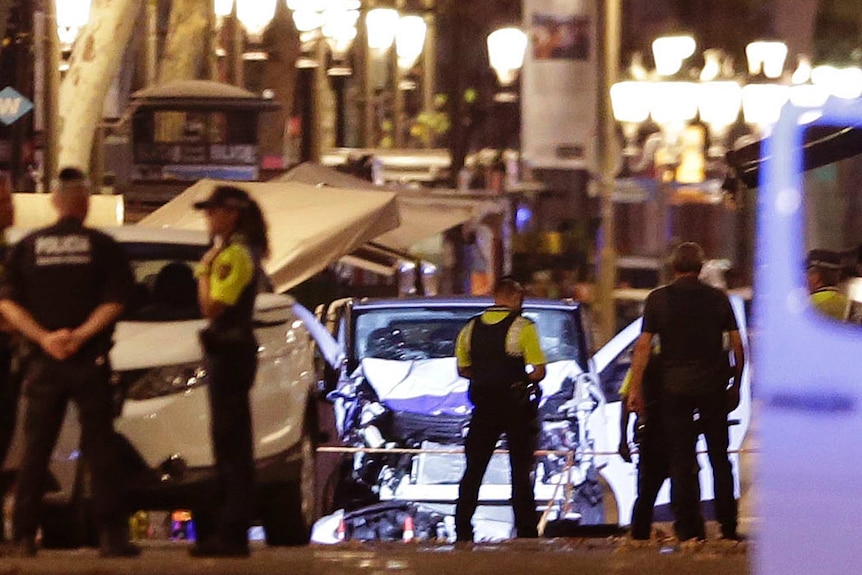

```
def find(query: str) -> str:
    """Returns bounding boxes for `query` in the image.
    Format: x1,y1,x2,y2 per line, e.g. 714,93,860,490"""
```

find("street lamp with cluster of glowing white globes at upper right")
600,36,810,300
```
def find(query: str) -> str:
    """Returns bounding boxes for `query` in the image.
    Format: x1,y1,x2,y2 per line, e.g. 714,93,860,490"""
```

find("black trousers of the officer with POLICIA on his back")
13,352,126,540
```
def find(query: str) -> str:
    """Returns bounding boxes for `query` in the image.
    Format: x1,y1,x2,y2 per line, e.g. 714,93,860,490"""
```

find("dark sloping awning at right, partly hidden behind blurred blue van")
725,125,862,188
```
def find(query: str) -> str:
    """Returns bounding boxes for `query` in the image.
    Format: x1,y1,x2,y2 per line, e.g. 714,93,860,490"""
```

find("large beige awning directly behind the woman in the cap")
137,180,399,292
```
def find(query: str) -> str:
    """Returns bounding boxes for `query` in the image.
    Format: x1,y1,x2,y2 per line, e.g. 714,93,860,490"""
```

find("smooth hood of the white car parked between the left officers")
111,320,206,371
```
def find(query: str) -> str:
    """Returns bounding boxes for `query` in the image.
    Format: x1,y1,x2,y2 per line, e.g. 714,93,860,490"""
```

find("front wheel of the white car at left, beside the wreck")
262,432,316,546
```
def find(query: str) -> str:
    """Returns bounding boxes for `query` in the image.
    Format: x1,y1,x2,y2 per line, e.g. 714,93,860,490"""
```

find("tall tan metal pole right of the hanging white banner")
596,0,621,344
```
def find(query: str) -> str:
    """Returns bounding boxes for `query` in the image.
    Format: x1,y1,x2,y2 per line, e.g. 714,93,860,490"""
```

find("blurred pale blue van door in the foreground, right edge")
753,98,862,575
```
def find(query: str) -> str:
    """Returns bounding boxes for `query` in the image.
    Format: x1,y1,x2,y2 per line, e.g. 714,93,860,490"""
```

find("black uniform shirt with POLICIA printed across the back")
0,218,134,353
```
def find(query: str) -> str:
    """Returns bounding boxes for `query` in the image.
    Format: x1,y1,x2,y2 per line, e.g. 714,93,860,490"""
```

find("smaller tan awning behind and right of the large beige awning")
280,162,501,251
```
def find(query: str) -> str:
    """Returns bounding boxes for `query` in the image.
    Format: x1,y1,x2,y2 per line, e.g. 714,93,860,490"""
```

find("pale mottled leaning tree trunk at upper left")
57,0,141,170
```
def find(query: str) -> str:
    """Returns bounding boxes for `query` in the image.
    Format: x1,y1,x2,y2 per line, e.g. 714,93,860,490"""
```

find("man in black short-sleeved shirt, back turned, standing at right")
628,242,745,541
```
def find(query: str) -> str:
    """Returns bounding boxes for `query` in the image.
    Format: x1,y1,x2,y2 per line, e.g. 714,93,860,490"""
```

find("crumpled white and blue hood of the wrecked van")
360,357,582,415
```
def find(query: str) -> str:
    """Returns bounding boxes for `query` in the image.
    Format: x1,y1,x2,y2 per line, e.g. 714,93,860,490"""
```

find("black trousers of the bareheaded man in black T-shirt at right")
662,390,737,541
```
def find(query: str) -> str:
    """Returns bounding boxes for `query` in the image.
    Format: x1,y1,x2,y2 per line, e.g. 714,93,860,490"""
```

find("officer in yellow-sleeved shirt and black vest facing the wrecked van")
455,277,546,542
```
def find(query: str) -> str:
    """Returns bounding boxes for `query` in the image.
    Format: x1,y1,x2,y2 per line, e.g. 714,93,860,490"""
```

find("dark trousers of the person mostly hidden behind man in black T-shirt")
631,426,672,539
